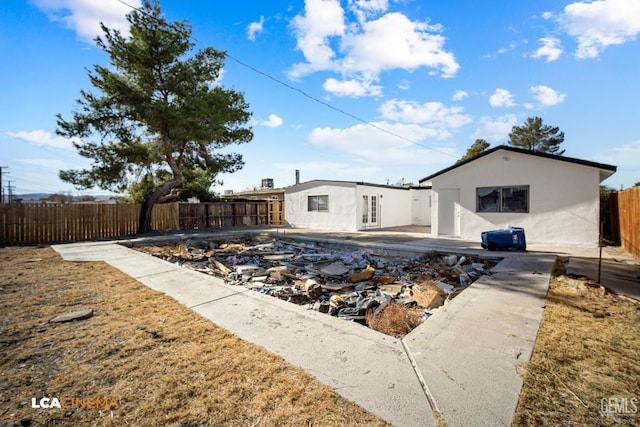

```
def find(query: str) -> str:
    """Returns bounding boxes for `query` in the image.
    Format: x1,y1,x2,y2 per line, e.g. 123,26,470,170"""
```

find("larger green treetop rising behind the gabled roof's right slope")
509,117,565,155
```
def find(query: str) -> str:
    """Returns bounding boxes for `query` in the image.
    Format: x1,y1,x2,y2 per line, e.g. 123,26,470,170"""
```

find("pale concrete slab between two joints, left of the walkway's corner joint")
193,292,437,426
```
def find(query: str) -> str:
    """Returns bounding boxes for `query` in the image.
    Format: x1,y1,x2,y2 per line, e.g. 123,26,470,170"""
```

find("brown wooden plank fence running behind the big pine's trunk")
0,200,284,245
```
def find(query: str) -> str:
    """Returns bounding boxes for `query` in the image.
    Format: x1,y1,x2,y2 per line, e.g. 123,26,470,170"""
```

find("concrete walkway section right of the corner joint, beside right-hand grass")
404,255,553,426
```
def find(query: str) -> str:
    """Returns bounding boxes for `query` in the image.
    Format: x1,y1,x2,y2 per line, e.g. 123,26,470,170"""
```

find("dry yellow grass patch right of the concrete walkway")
514,262,640,426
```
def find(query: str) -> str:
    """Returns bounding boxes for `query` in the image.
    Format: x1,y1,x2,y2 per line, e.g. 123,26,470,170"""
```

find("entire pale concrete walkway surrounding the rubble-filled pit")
54,230,584,426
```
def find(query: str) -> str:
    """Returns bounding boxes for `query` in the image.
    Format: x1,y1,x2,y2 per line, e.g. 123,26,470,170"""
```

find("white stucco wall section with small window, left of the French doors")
284,181,360,231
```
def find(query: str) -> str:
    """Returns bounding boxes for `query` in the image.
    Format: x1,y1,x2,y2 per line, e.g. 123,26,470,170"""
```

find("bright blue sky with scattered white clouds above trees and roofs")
0,0,640,194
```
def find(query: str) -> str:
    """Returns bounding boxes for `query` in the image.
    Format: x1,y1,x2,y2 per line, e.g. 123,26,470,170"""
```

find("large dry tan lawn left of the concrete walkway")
0,248,385,426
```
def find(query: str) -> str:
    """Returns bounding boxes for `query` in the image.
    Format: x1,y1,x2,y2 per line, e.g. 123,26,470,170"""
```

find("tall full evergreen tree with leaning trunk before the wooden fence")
57,0,253,233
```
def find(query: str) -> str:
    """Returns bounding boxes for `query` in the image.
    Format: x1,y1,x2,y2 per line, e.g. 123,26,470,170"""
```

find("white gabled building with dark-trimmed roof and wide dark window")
420,146,616,246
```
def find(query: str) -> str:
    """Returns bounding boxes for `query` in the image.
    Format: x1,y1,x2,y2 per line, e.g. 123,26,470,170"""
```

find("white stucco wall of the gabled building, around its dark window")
431,150,600,246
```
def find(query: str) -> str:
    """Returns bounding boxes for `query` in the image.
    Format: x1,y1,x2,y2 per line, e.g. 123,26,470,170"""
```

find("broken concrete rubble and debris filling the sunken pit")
138,239,498,332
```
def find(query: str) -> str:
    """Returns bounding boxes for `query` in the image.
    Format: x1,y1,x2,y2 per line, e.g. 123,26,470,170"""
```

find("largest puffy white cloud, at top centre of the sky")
289,0,460,90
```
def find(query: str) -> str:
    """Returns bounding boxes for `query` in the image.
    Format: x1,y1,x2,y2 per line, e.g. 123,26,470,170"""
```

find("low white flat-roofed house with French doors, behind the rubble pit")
284,180,431,231
